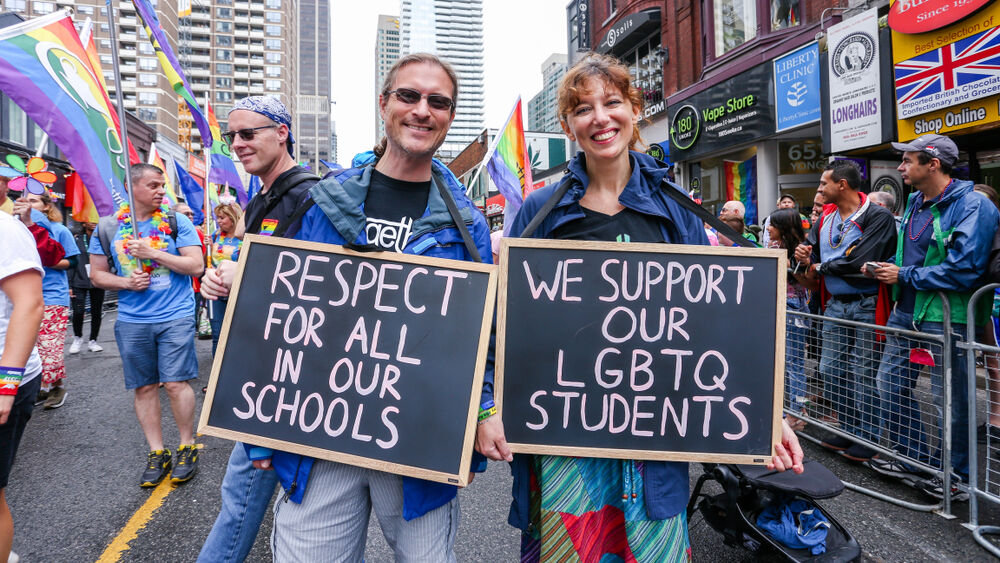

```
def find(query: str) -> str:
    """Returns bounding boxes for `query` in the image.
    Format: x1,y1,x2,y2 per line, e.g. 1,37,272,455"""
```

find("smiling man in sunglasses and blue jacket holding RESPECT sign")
245,53,492,561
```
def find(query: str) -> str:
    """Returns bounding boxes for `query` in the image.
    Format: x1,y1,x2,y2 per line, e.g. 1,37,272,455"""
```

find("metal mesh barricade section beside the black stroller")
784,294,964,518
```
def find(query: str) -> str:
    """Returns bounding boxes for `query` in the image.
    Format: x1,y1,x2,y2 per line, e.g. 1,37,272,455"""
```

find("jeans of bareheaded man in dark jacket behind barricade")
819,295,882,442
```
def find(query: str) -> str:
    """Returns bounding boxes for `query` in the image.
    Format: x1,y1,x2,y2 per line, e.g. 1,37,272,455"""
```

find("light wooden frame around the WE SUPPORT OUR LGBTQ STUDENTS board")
494,238,788,465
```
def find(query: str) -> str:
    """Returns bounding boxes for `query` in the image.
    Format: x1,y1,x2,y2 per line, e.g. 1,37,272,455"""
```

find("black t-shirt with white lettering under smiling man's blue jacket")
365,170,431,252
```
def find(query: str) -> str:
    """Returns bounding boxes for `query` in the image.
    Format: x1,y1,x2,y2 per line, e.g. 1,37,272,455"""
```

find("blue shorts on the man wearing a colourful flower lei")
115,315,198,389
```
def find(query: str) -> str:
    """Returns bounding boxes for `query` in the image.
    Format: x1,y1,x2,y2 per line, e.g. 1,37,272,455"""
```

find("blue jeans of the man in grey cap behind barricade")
878,311,969,478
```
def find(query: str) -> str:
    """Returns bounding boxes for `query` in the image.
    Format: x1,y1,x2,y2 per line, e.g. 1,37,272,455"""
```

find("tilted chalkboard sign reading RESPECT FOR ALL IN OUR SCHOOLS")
199,235,496,485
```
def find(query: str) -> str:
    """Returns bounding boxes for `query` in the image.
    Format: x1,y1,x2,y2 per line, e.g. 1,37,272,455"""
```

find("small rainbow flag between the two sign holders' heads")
486,96,534,215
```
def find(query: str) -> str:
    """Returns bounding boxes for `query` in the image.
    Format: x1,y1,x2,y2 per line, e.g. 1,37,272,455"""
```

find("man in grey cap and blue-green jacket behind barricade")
870,134,1000,500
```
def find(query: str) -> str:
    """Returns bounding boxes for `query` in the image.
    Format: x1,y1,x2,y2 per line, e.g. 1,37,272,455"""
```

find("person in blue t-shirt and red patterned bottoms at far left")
15,191,80,409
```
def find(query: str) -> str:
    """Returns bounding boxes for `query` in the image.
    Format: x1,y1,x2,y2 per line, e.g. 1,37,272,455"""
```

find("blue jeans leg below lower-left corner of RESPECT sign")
198,442,278,563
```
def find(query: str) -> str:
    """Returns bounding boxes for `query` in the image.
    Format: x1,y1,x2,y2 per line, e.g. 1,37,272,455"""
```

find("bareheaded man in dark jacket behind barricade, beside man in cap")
795,160,896,461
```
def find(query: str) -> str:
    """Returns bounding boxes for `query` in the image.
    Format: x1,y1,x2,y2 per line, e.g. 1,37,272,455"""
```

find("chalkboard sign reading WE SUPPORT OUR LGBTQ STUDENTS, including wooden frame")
495,239,787,464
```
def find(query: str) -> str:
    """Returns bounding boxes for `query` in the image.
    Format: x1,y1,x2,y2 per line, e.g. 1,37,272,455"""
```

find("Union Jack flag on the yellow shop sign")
895,27,1000,119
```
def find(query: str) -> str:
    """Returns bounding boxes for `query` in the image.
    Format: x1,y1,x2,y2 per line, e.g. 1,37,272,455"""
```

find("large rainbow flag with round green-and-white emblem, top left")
0,11,128,215
